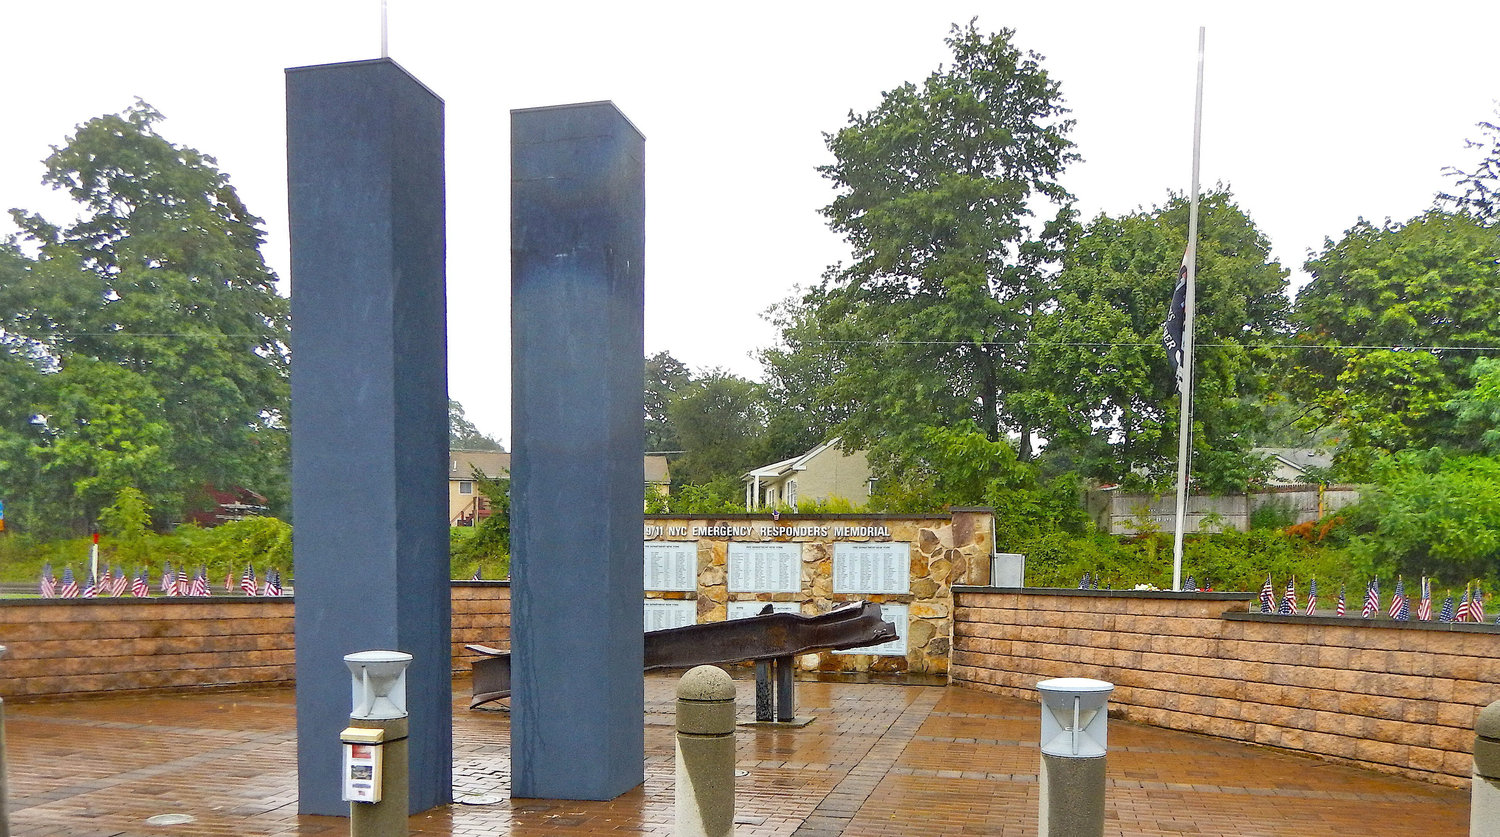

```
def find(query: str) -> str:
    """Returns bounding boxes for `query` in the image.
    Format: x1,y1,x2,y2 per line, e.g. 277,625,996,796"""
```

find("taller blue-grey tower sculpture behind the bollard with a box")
287,59,450,816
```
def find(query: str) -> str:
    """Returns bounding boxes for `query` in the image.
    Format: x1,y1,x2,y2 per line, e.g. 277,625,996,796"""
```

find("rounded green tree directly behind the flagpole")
1038,191,1287,491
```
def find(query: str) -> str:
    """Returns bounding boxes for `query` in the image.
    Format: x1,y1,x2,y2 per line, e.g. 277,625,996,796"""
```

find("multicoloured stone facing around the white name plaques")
647,509,995,675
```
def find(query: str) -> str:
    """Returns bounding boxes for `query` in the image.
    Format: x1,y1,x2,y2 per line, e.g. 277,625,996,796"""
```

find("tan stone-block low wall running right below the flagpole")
951,588,1500,786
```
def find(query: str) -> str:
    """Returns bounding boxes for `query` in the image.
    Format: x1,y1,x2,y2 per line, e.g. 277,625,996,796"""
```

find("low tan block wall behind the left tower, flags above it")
0,582,510,701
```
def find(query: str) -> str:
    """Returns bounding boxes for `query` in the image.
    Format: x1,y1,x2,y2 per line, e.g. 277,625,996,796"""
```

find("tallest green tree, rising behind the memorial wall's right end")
809,21,1079,462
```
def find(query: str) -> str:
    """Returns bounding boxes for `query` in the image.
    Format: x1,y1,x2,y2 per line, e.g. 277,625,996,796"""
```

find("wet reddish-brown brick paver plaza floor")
6,675,1469,837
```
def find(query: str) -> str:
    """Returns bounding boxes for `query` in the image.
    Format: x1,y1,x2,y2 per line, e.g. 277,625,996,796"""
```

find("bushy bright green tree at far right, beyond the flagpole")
1289,210,1500,480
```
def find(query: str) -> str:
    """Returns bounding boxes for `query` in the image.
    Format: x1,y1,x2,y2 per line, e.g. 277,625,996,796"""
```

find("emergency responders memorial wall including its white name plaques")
642,509,995,675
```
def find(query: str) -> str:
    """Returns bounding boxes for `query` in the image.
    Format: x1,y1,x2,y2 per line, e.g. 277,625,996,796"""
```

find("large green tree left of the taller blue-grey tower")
0,102,288,525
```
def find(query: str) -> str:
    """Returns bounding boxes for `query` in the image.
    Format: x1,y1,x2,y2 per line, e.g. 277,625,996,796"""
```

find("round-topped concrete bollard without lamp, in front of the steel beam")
672,666,735,837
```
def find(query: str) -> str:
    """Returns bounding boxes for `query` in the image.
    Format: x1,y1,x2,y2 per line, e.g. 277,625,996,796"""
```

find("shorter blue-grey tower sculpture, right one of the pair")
510,102,645,800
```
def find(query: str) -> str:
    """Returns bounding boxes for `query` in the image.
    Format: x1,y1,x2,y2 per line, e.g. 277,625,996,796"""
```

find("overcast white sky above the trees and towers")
0,0,1500,443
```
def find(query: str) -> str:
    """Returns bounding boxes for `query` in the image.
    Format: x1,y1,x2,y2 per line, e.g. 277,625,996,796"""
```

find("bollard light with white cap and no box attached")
1037,677,1115,837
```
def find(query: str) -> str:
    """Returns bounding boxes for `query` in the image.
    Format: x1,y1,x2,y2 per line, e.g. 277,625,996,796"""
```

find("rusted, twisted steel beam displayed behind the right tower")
465,602,897,710
